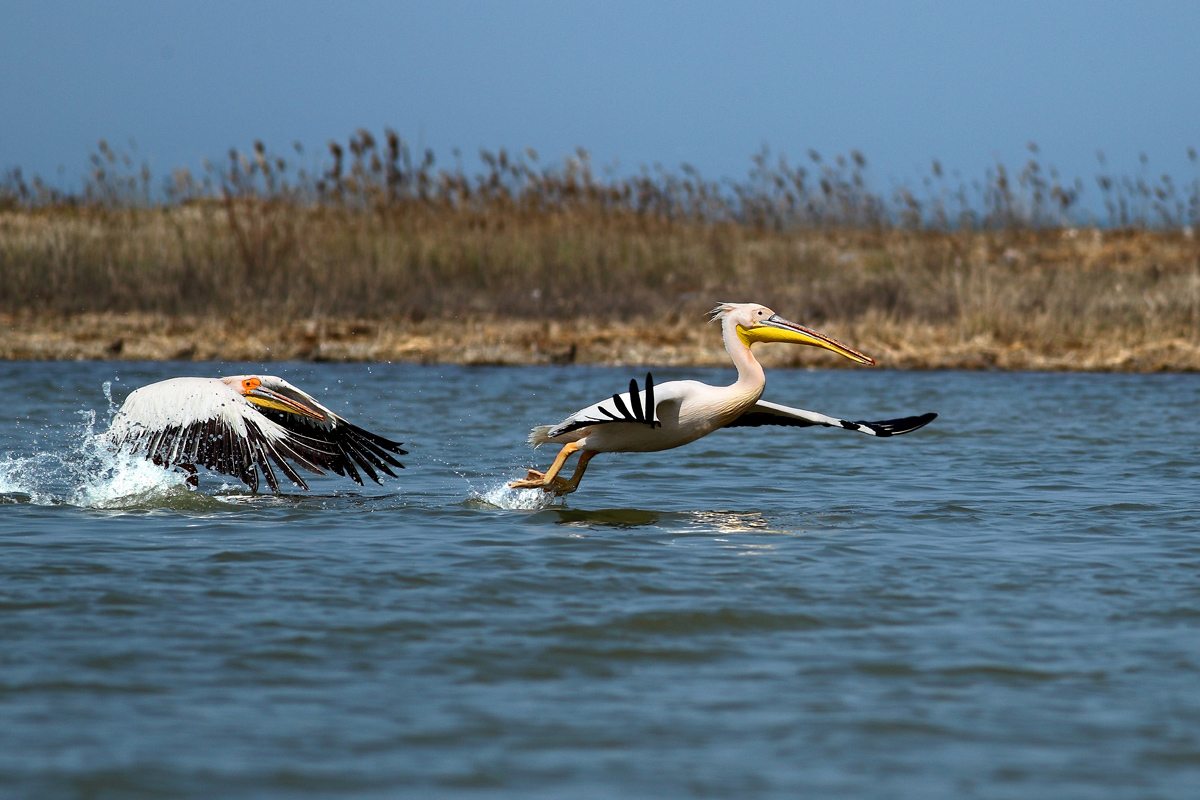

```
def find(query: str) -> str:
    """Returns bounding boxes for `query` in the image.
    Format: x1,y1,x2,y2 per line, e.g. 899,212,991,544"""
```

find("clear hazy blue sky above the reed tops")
0,0,1200,188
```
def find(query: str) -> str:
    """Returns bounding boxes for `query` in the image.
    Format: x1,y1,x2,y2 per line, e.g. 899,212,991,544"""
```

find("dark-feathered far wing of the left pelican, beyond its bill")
252,375,408,486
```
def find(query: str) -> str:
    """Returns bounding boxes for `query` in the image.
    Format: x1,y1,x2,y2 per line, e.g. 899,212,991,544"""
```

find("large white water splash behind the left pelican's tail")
0,391,190,509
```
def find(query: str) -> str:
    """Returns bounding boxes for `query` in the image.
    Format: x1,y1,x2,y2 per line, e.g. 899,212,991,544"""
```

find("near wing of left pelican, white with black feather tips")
107,378,336,492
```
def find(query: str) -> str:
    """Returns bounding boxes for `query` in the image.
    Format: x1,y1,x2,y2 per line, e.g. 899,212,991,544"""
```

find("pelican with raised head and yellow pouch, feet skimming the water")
509,303,937,495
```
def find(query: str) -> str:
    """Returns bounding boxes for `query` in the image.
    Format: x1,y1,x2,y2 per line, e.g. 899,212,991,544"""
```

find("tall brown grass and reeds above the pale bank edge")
0,131,1200,352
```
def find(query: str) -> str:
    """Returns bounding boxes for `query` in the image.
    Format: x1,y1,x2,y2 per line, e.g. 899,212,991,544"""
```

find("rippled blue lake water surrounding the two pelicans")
0,362,1200,799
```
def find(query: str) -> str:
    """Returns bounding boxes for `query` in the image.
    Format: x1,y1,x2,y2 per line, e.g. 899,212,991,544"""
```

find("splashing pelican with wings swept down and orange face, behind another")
108,375,407,492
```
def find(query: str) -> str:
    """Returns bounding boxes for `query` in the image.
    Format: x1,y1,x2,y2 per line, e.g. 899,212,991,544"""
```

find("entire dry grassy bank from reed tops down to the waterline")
0,133,1200,369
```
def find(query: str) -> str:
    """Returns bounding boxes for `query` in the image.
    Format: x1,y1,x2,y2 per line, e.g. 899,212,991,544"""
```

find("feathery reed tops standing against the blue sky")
0,126,1200,228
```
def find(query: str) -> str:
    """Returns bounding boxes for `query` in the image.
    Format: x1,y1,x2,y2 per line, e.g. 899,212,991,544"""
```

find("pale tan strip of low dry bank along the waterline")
0,313,1200,372
